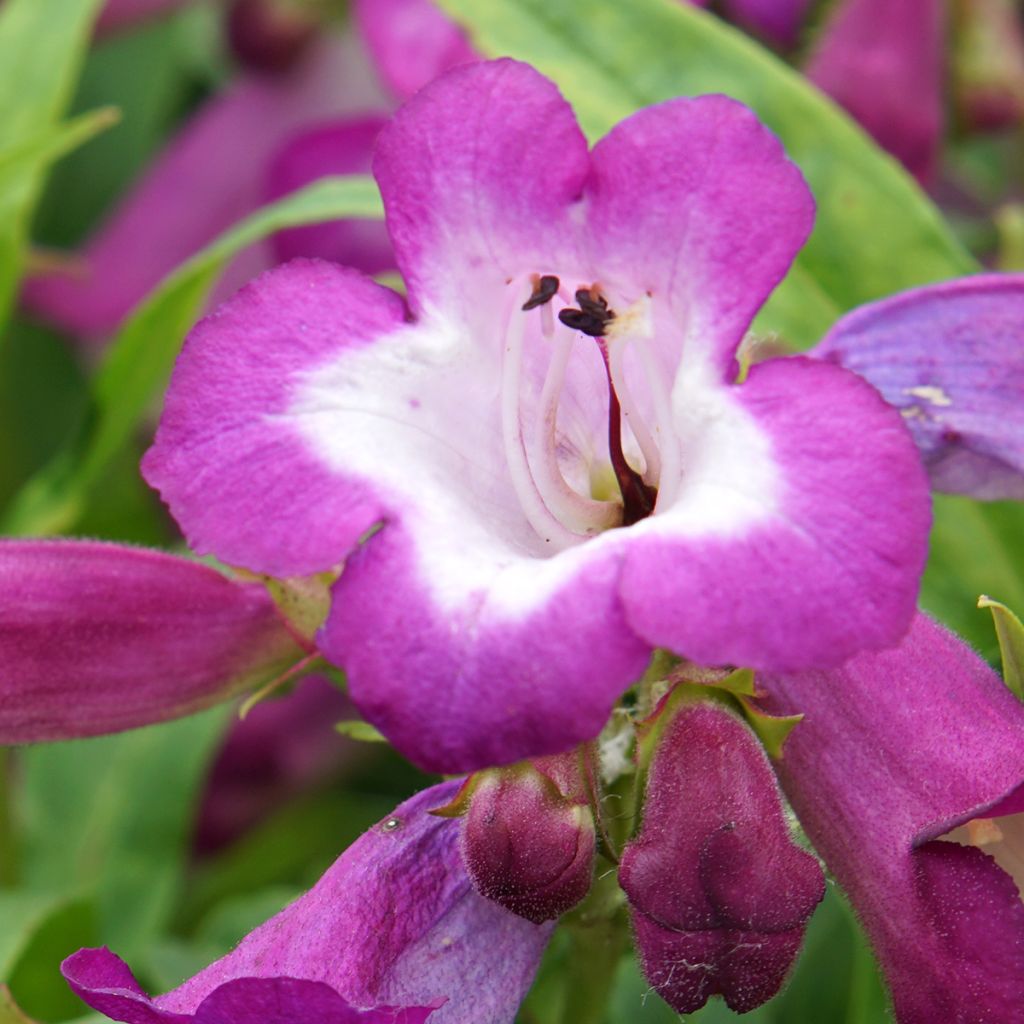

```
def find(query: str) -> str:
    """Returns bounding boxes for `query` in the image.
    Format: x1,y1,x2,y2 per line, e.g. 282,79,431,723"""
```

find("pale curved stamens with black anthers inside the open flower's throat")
502,274,669,547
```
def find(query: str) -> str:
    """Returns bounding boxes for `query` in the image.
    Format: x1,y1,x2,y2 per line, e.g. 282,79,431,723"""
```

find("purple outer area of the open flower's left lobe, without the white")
142,260,406,578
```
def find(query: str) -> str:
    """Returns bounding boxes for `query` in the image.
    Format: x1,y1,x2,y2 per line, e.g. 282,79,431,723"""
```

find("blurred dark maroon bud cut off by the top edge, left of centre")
226,0,323,74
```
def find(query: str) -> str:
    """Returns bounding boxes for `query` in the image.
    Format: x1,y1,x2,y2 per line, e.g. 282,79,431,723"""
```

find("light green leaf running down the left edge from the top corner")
0,0,101,326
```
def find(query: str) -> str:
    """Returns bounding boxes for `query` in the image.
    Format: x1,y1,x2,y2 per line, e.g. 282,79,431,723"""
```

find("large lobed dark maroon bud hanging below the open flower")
620,687,824,1014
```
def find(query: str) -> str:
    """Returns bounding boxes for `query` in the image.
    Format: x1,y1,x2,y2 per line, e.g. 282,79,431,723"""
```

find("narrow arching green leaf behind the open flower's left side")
3,176,382,535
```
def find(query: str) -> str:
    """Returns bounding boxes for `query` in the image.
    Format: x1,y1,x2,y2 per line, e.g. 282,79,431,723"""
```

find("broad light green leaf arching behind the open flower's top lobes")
440,0,977,345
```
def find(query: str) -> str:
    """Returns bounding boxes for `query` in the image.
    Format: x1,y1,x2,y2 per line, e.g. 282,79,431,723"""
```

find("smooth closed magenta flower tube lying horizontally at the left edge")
0,541,303,743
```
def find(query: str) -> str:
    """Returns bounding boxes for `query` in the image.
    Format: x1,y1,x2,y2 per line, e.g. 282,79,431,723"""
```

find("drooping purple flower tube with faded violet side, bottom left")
65,782,551,1024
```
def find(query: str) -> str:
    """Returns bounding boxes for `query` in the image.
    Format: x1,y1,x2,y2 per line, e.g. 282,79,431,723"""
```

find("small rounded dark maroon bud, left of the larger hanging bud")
462,751,596,924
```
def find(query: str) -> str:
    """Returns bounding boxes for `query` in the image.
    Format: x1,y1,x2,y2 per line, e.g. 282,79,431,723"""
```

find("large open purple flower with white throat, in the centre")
143,60,929,771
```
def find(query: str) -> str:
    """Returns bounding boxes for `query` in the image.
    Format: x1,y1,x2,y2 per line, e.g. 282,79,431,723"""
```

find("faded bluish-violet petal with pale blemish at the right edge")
813,274,1024,500
